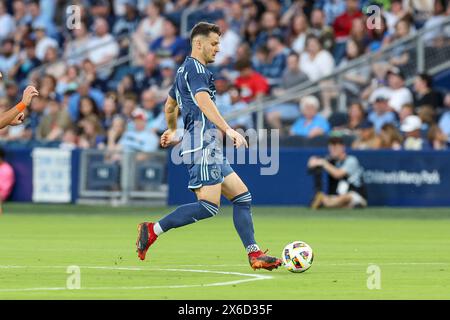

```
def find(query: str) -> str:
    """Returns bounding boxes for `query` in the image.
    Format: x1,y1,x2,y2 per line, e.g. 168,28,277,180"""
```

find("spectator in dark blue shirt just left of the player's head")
150,19,188,63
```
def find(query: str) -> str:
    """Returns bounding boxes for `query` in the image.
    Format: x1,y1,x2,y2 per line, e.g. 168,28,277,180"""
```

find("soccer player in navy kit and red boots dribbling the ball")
136,22,281,270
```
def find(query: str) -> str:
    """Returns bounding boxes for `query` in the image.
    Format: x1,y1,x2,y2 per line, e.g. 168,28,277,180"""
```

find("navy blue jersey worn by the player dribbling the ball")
169,56,216,155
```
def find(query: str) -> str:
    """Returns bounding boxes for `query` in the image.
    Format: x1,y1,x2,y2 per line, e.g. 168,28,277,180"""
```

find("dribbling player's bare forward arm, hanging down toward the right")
195,91,248,148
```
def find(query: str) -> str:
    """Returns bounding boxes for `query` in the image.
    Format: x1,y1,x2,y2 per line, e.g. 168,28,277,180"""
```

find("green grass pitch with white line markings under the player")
0,204,450,299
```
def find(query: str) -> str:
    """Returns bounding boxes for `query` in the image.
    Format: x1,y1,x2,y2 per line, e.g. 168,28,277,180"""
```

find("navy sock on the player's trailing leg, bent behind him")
159,200,219,232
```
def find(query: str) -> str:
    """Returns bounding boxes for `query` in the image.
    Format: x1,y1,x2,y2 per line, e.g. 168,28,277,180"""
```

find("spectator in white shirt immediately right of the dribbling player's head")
214,17,241,67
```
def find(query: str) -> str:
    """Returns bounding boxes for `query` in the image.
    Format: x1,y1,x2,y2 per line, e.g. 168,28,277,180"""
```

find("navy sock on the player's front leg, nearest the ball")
231,191,259,253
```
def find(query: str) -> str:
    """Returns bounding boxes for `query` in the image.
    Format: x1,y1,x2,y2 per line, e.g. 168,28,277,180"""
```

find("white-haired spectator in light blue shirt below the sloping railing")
290,96,330,138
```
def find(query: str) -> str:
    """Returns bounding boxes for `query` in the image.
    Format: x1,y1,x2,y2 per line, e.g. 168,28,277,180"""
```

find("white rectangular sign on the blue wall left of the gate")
32,148,72,203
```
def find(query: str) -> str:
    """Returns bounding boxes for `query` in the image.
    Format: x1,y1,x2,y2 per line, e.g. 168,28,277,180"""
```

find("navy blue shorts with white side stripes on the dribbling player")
187,148,234,189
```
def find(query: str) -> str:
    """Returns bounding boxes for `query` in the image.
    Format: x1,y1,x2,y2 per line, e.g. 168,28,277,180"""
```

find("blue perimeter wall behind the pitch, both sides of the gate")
6,148,450,207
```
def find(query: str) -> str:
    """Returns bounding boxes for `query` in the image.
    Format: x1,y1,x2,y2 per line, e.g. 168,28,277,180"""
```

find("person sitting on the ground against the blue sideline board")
308,137,367,209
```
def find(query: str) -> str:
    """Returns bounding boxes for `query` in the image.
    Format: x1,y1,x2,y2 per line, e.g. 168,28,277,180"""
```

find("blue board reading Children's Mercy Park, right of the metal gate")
168,149,450,207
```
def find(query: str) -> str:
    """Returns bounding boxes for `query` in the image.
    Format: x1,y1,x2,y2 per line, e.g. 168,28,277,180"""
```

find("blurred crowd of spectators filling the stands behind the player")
0,0,450,151
